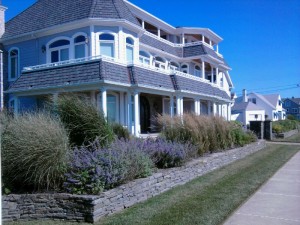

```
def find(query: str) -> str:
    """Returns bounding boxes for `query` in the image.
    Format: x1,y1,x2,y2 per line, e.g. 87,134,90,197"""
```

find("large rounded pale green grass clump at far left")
2,113,69,190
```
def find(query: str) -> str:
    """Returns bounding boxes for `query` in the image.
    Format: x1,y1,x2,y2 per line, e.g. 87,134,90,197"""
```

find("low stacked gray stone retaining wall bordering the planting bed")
2,141,266,222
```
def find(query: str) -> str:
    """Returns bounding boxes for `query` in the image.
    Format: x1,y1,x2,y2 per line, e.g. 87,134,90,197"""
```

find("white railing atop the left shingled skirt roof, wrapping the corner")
23,55,124,72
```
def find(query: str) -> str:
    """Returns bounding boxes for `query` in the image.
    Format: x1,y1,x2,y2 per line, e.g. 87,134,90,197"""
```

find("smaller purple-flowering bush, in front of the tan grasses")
142,138,197,168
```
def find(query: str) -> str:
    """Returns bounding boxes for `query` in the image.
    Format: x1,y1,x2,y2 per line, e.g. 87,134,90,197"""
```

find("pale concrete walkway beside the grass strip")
224,149,300,225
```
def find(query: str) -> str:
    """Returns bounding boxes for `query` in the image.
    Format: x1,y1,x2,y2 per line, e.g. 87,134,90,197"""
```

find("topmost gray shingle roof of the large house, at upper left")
3,0,140,38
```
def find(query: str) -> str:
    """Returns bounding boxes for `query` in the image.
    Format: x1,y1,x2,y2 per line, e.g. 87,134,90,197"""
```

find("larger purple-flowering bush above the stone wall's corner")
64,140,153,194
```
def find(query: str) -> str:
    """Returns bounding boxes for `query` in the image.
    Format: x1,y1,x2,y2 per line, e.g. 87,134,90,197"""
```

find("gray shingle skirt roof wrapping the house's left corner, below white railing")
9,60,130,92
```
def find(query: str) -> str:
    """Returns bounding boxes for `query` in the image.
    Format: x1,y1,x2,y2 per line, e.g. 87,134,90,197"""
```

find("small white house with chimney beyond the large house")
231,90,286,125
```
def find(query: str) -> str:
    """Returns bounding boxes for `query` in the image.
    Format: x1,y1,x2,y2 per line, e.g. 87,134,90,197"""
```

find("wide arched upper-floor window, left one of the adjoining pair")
49,40,70,63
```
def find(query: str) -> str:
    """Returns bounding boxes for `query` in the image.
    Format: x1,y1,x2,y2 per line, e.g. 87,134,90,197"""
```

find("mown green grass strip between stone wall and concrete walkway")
5,145,300,225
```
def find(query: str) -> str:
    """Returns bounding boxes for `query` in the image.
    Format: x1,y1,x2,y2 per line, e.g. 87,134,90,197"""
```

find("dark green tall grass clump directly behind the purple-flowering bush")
55,95,114,146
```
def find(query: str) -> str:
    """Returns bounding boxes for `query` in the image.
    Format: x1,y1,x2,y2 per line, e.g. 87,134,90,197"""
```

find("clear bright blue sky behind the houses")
2,0,300,98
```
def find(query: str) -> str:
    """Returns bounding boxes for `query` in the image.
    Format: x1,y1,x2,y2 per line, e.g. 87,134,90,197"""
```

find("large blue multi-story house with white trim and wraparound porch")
0,0,233,136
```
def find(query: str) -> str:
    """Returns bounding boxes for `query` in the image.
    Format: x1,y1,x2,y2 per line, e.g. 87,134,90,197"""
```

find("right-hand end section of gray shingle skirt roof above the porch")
173,75,230,100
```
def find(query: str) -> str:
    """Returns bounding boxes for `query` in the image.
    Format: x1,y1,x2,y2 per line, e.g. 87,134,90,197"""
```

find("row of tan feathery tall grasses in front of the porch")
157,114,253,155
